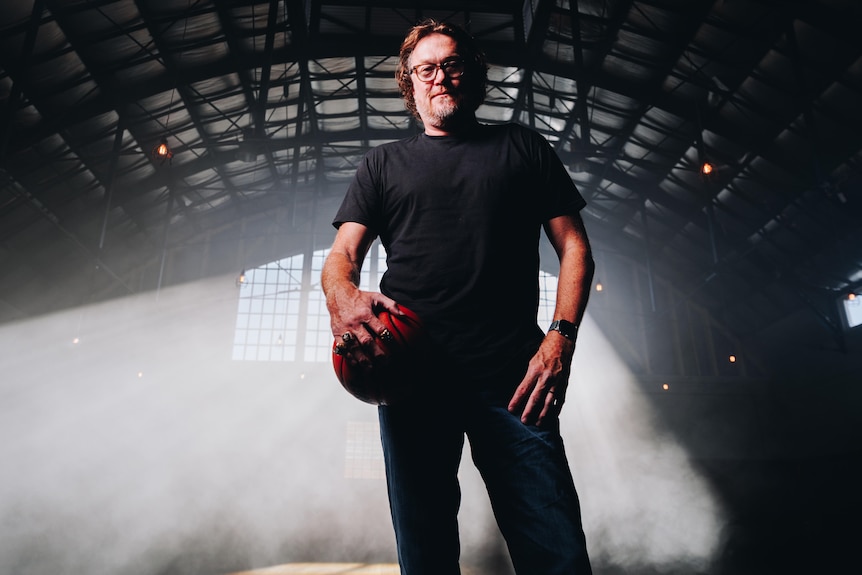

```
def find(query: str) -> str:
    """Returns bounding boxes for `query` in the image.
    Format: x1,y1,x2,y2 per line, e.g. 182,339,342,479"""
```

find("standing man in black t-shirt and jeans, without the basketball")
322,21,593,575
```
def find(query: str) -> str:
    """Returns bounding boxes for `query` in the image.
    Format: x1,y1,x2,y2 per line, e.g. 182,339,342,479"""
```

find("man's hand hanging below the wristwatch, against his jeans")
509,331,575,426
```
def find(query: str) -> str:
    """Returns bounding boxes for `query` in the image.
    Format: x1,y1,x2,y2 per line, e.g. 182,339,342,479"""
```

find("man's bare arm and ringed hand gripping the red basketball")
320,222,400,364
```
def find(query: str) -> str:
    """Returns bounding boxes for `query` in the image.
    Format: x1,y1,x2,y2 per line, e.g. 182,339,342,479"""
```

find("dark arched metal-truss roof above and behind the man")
0,0,862,364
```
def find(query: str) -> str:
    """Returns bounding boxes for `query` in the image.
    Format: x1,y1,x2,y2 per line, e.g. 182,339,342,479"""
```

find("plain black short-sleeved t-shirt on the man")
333,124,585,373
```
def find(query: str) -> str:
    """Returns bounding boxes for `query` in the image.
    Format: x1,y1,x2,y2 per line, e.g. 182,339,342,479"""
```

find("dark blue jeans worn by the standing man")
379,377,591,575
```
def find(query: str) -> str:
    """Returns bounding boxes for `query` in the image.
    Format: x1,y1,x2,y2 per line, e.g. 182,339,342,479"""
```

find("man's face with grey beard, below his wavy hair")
410,34,465,134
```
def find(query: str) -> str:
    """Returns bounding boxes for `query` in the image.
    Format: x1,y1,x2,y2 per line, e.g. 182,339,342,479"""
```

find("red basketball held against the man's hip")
332,306,426,405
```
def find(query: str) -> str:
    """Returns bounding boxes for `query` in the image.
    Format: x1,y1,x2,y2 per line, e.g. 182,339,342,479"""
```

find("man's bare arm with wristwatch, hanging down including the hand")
509,214,595,424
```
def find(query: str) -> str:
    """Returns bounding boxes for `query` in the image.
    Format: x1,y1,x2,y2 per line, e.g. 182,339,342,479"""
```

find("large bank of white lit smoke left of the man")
0,279,393,575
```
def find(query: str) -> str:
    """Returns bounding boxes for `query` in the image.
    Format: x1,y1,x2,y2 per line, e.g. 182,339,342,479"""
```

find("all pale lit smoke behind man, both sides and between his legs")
0,278,720,575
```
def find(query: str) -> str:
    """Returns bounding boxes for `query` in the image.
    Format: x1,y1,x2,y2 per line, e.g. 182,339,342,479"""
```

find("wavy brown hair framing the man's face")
395,19,488,120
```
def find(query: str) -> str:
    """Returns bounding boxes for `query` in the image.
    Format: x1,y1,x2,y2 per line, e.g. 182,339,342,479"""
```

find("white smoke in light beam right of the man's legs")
562,317,724,573
